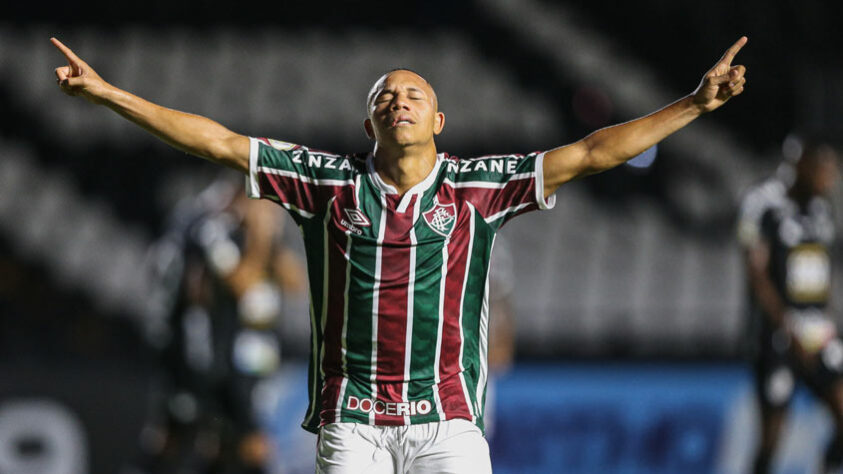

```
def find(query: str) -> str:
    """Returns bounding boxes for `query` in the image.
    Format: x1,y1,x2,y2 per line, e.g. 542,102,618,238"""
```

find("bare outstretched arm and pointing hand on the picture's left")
50,38,249,172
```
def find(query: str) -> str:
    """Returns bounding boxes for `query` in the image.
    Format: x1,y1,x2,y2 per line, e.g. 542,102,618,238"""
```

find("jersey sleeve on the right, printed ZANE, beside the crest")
449,153,556,228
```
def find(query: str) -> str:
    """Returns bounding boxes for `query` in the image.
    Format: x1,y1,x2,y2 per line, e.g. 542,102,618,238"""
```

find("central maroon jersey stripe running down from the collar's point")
375,195,418,425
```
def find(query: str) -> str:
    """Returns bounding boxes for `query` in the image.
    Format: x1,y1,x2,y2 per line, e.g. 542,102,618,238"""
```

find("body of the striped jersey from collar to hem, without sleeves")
308,159,494,430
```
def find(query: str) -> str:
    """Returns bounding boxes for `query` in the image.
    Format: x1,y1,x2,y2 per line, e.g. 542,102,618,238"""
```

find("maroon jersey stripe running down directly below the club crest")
439,206,471,420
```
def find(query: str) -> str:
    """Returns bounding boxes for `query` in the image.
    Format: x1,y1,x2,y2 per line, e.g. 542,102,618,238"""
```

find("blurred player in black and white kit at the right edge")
738,142,843,473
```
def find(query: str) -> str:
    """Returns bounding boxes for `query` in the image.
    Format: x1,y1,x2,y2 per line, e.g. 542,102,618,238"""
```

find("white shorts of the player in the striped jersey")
316,419,492,474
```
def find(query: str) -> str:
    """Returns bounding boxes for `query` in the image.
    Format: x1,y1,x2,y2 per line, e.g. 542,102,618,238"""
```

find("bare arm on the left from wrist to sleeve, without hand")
98,86,249,172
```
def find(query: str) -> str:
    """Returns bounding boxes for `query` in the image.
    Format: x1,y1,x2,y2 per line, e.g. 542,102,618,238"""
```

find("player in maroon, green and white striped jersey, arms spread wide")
51,37,747,473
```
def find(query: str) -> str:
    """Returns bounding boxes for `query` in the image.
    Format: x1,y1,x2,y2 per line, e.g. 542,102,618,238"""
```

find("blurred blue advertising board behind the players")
266,362,831,474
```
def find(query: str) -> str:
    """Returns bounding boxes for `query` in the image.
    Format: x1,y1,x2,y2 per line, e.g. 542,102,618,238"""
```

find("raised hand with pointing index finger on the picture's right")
693,36,747,112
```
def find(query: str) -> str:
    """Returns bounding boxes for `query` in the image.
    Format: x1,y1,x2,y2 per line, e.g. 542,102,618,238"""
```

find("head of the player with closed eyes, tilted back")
365,70,445,147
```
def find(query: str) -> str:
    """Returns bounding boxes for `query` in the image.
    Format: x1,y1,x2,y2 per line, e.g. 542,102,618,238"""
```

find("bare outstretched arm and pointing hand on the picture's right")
544,36,747,197
